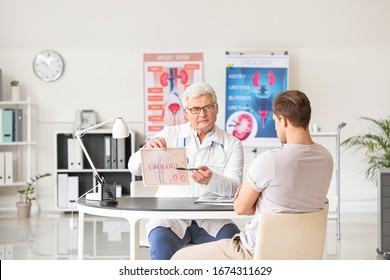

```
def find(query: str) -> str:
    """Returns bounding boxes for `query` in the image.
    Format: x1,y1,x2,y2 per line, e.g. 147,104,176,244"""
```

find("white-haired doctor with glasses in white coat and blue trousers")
129,83,244,260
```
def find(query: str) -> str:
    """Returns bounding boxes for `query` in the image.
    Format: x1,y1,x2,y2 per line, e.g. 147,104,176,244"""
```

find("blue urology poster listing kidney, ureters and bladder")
225,54,288,147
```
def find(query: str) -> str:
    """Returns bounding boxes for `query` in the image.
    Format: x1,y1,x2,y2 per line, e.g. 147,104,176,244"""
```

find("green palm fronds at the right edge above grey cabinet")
341,117,390,183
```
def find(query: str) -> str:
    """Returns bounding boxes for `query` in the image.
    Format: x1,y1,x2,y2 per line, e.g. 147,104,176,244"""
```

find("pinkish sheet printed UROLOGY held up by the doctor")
141,148,189,186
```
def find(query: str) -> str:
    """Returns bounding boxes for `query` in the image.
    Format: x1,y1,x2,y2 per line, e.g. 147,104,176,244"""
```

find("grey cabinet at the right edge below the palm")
377,168,390,259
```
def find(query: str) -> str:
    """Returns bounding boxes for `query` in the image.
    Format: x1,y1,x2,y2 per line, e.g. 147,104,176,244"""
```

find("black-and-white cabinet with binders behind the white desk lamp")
54,129,135,211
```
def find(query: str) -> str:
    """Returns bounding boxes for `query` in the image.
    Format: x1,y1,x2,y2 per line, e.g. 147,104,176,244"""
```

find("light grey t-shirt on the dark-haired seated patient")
240,143,333,253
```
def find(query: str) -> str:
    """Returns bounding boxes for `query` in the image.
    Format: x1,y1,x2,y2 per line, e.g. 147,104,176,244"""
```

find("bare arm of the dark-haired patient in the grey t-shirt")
234,180,261,215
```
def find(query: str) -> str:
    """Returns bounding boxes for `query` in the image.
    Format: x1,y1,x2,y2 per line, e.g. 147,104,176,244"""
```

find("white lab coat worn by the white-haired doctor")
128,122,244,238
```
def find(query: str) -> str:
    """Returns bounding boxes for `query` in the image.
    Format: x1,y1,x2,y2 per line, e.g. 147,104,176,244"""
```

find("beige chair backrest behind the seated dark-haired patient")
254,209,328,260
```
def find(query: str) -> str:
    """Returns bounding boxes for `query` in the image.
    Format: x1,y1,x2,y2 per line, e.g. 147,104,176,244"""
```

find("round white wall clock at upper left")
33,50,64,82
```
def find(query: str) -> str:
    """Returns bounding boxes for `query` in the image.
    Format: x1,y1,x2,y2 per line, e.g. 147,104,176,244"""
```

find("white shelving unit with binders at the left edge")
0,98,35,194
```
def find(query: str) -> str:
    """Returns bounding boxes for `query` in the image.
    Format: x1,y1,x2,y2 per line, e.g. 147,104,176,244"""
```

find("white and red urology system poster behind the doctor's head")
144,53,203,141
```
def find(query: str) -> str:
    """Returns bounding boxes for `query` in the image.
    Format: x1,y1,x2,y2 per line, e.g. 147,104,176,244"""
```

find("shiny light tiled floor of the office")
0,213,383,260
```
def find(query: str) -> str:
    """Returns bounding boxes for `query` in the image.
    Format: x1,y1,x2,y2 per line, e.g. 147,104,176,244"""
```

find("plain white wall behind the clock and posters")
0,0,390,211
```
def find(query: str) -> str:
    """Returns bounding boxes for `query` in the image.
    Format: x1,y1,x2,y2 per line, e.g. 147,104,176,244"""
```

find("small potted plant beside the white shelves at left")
16,173,51,218
